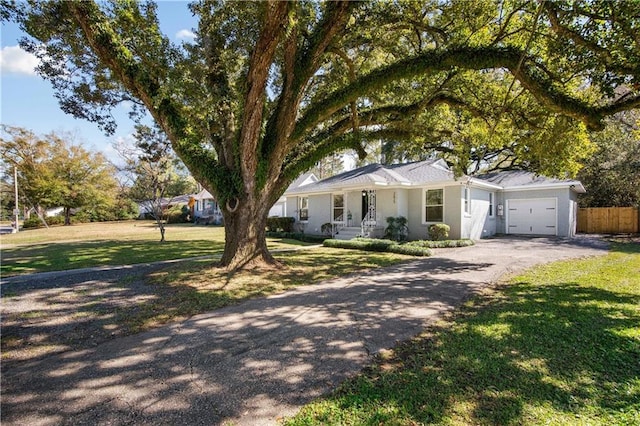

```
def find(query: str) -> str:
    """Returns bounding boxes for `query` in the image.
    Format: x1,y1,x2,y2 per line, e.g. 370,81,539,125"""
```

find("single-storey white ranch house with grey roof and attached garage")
277,160,585,240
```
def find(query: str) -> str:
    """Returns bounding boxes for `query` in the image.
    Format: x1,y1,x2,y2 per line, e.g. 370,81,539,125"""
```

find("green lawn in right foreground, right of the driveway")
286,243,640,425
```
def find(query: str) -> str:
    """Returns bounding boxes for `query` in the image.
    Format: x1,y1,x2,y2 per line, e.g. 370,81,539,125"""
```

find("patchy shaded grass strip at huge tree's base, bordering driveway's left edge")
1,248,411,365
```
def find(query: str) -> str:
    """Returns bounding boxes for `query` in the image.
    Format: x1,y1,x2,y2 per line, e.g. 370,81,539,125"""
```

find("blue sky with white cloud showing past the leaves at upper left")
0,1,197,161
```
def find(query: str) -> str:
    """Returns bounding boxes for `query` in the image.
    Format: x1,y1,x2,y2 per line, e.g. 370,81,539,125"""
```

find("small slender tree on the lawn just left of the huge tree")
115,125,195,242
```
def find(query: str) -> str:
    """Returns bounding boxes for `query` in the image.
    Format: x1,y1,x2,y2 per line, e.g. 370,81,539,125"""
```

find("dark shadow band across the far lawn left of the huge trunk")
0,240,224,277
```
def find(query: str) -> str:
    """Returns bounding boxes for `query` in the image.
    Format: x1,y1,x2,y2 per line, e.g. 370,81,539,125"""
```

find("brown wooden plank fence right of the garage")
578,207,640,234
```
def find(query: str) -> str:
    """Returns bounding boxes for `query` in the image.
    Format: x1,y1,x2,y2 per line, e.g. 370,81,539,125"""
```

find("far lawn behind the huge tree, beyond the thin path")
0,221,318,276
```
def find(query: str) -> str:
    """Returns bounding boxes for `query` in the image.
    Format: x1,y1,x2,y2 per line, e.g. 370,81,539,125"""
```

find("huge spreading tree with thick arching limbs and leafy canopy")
3,0,640,269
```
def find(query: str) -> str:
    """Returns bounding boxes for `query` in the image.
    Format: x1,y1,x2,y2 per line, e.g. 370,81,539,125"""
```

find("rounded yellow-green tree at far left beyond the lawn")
0,126,116,225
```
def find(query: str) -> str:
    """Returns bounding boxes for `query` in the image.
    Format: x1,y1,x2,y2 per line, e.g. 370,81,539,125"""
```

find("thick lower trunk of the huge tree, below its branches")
220,193,280,271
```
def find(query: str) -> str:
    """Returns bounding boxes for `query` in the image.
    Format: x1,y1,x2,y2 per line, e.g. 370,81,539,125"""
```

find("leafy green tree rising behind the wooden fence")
578,110,640,207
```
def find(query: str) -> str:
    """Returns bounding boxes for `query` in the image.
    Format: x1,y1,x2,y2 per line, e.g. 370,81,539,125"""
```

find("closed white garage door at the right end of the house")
507,198,558,235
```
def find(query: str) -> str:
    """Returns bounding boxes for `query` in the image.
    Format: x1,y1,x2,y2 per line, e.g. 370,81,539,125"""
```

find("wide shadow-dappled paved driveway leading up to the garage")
2,238,607,425
